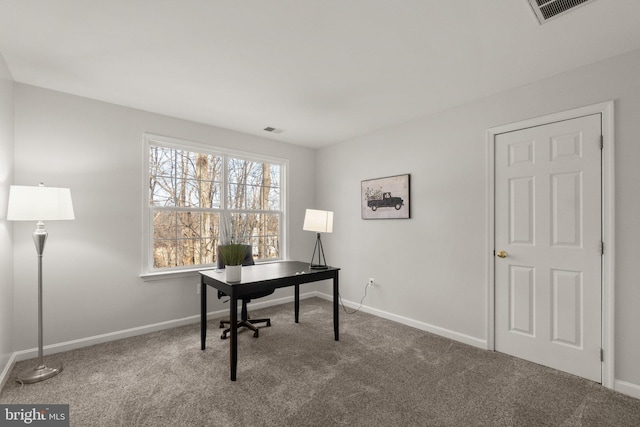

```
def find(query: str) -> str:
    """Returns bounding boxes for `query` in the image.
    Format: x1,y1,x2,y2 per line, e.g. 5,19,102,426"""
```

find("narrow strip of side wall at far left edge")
0,54,13,386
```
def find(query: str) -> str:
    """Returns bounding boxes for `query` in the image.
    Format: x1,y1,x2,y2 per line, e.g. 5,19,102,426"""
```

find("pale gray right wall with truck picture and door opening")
316,46,640,397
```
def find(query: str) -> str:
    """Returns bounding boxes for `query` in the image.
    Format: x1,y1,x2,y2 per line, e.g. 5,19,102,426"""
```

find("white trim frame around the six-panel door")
486,101,615,389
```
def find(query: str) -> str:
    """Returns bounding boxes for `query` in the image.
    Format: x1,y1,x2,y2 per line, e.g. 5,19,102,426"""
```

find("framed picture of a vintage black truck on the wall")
360,174,411,219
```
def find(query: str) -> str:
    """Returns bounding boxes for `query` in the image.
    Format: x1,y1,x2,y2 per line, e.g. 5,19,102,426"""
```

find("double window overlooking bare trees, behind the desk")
145,135,285,272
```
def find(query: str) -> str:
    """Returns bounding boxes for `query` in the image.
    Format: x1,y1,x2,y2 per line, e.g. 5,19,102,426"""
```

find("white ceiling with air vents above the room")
0,0,640,147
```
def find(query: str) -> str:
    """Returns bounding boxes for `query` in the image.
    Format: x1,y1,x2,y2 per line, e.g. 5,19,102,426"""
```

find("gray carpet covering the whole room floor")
0,298,640,427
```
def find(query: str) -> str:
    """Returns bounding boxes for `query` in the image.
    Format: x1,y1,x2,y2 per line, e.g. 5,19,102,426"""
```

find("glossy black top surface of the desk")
198,261,340,286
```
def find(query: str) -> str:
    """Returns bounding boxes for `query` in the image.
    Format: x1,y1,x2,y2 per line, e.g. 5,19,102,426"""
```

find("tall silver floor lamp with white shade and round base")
7,184,75,384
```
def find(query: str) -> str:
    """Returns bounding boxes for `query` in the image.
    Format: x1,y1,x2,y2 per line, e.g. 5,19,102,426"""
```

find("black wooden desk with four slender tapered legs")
198,261,340,381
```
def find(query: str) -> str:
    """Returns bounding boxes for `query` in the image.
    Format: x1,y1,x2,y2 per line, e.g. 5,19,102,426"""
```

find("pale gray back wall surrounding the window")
13,84,315,351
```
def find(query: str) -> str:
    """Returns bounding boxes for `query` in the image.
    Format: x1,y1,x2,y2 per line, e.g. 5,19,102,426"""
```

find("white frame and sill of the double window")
140,133,289,280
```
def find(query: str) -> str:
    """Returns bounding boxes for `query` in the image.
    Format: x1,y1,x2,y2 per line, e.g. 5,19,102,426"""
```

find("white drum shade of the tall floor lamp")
7,185,75,221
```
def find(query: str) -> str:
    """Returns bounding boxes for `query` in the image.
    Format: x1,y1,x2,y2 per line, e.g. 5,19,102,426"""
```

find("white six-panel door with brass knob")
494,114,602,382
